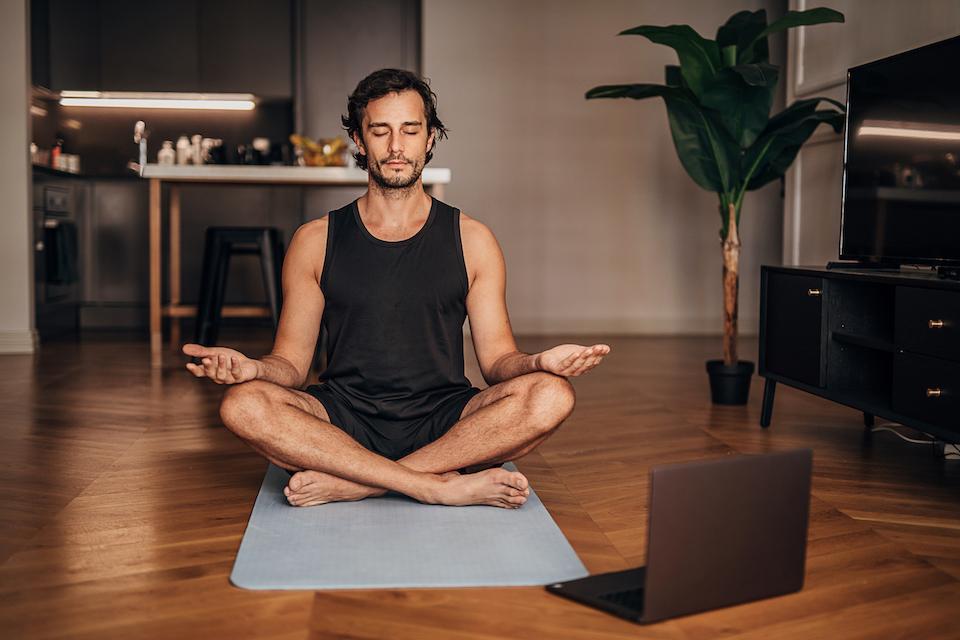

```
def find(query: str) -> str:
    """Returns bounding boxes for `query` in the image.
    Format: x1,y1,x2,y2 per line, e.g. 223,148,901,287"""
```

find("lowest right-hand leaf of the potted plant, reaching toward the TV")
741,98,844,191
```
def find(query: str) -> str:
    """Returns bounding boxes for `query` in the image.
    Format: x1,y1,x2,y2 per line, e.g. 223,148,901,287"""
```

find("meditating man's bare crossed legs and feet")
220,371,575,508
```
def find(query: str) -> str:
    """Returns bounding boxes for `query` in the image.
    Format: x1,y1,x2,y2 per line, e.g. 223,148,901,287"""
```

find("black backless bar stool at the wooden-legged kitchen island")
194,227,283,347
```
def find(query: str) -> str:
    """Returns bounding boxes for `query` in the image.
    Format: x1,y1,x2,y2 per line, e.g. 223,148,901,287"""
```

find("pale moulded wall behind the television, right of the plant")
783,0,960,266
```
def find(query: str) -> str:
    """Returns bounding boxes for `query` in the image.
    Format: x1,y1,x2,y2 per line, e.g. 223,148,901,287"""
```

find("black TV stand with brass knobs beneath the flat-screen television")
758,266,960,442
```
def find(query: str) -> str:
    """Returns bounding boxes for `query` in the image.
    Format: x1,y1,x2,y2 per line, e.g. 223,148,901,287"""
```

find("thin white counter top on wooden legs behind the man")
141,164,450,185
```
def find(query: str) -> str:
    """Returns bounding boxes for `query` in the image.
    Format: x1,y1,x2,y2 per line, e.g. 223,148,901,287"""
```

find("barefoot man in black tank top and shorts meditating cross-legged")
183,69,610,508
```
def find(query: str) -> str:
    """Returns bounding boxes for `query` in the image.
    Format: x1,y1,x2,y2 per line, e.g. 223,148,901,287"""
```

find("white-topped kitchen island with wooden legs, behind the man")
141,164,450,367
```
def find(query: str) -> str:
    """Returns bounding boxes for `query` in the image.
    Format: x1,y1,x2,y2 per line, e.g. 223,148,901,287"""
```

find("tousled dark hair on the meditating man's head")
340,69,447,170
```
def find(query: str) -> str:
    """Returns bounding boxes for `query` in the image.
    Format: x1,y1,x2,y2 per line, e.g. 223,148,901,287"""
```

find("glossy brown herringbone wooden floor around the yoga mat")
0,331,960,639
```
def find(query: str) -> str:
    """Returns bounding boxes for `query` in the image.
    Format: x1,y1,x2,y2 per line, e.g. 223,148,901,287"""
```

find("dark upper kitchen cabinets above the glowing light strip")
31,0,294,99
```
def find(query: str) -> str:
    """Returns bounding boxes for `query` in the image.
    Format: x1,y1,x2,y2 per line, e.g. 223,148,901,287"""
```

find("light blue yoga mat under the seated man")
230,464,588,590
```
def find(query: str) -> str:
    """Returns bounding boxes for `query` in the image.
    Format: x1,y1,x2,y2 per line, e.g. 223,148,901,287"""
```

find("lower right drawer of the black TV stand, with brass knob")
892,352,960,430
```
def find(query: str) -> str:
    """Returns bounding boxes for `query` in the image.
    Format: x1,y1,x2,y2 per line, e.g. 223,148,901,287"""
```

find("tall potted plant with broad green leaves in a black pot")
586,8,844,404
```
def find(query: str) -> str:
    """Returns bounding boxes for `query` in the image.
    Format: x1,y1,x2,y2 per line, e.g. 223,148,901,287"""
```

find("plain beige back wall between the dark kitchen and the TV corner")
422,0,785,334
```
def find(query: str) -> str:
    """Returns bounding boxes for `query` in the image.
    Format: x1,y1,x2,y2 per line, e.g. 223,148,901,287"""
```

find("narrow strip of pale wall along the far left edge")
0,0,37,353
